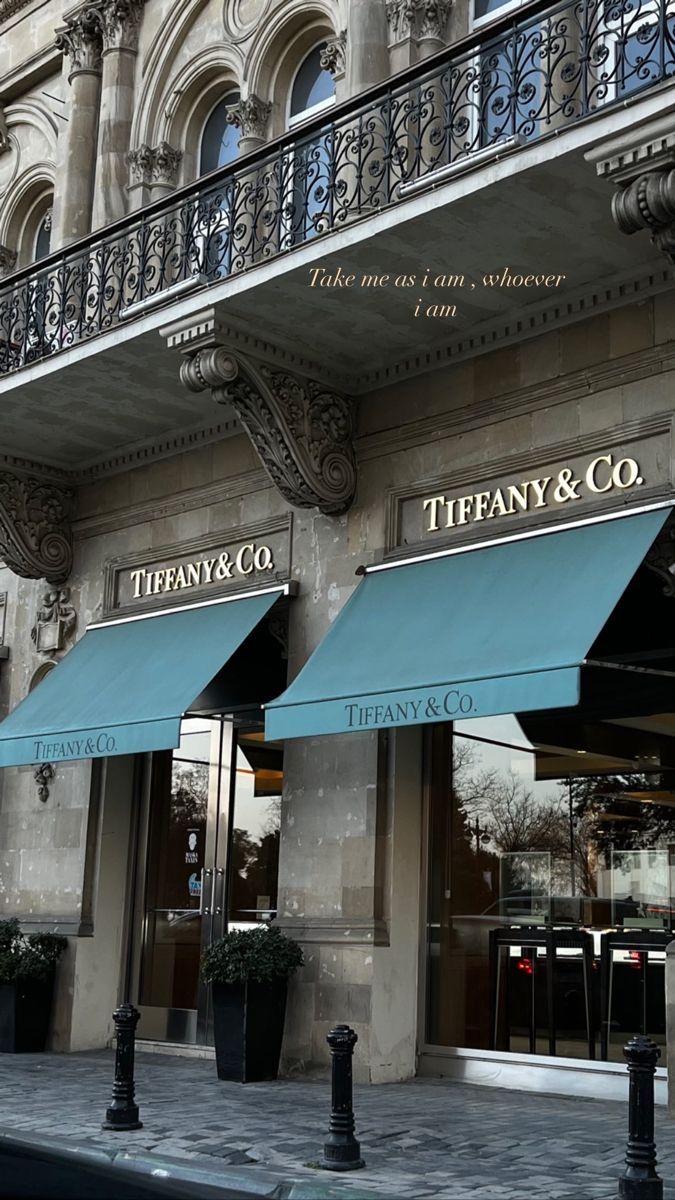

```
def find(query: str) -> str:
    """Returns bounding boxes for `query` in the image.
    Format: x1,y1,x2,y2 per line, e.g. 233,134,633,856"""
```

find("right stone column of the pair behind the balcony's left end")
91,0,143,229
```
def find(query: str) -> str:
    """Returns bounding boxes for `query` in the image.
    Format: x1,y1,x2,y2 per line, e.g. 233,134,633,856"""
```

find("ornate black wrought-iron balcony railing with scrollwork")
0,0,675,373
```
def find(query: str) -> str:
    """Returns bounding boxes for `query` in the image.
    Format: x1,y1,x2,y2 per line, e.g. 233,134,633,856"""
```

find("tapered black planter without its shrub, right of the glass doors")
211,979,283,1084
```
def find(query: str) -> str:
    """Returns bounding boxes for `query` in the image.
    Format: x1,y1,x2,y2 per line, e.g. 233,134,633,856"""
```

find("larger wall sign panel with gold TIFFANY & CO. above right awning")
388,420,673,551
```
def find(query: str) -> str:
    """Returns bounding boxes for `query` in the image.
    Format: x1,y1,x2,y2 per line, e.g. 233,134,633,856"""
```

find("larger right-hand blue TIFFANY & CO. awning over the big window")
265,509,670,738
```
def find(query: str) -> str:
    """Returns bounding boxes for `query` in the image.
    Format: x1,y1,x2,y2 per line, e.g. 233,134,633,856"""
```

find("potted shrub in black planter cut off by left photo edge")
0,918,67,1054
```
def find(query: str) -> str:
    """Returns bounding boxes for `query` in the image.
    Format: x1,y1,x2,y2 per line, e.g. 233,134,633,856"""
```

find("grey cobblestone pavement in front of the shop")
0,1051,675,1200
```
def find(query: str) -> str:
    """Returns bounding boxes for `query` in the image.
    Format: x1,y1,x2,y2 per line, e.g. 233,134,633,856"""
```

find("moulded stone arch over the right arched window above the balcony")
244,0,341,137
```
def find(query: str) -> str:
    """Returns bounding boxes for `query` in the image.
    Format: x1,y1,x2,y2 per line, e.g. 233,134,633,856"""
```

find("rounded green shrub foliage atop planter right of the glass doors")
202,925,303,983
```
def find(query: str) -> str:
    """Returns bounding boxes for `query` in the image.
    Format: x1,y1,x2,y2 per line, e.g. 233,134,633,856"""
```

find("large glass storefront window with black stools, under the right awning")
425,714,675,1063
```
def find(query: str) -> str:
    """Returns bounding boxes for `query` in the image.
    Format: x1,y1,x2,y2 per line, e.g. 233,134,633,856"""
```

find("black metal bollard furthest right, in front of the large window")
619,1034,663,1200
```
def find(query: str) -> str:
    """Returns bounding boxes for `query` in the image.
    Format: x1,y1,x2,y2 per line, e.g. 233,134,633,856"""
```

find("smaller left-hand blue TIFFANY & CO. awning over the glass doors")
0,588,283,767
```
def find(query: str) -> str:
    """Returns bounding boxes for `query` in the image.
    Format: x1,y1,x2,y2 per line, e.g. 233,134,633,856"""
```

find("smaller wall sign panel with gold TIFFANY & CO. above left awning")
103,516,291,617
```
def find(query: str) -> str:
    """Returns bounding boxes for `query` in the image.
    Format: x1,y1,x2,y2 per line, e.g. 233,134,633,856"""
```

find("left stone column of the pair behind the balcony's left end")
52,8,101,250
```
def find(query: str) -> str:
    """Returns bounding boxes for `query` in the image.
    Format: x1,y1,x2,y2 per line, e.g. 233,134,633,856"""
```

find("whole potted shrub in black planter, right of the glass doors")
202,925,303,1084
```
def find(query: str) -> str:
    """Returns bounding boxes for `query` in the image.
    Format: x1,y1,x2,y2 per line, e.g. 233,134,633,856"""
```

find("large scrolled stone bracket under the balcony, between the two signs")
180,347,357,514
